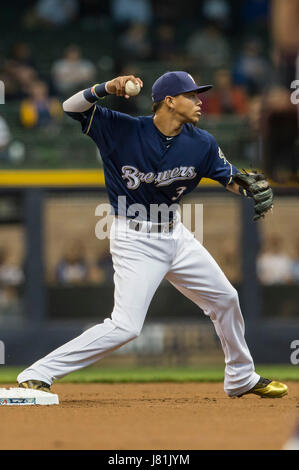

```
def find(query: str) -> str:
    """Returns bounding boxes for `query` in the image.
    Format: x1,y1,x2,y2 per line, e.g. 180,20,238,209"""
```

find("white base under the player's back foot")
0,387,59,406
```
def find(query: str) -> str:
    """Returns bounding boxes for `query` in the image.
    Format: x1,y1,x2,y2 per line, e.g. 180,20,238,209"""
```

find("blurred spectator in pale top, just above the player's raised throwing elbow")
52,46,96,95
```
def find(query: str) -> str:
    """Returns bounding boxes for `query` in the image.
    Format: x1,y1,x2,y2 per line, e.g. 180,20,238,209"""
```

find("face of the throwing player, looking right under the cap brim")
174,91,202,125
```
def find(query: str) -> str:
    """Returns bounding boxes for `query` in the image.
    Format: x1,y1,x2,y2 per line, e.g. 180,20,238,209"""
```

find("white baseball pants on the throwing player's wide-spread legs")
17,217,260,396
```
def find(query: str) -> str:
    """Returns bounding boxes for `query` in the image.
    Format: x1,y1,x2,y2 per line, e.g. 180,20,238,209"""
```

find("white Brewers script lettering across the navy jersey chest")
122,165,197,189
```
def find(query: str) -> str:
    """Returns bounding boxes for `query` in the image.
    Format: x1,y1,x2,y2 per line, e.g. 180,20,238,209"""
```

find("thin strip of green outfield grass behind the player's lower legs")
0,364,299,384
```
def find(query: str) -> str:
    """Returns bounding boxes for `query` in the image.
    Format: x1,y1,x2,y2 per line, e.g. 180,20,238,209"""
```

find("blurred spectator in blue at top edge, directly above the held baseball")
111,0,152,24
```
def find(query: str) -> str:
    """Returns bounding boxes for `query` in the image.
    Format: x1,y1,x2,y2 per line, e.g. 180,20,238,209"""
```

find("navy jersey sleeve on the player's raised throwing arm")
67,105,133,157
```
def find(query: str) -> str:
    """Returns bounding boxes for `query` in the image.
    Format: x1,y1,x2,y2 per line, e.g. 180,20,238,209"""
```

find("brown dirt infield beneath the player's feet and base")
0,382,299,450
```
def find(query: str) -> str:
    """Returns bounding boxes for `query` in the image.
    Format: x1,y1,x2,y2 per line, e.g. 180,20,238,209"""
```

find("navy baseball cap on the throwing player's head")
152,72,213,102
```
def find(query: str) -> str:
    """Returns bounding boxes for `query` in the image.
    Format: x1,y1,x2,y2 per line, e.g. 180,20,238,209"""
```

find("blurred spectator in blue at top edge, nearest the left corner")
35,0,79,26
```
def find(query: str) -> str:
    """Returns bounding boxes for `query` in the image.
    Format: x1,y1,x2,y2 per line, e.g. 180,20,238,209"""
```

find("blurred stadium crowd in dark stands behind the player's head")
0,0,297,173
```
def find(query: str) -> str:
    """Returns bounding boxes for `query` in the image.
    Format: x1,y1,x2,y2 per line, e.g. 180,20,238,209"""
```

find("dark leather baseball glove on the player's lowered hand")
233,170,273,221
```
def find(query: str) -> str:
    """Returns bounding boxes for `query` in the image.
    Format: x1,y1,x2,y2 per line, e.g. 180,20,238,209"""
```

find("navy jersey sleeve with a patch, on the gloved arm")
205,136,239,186
